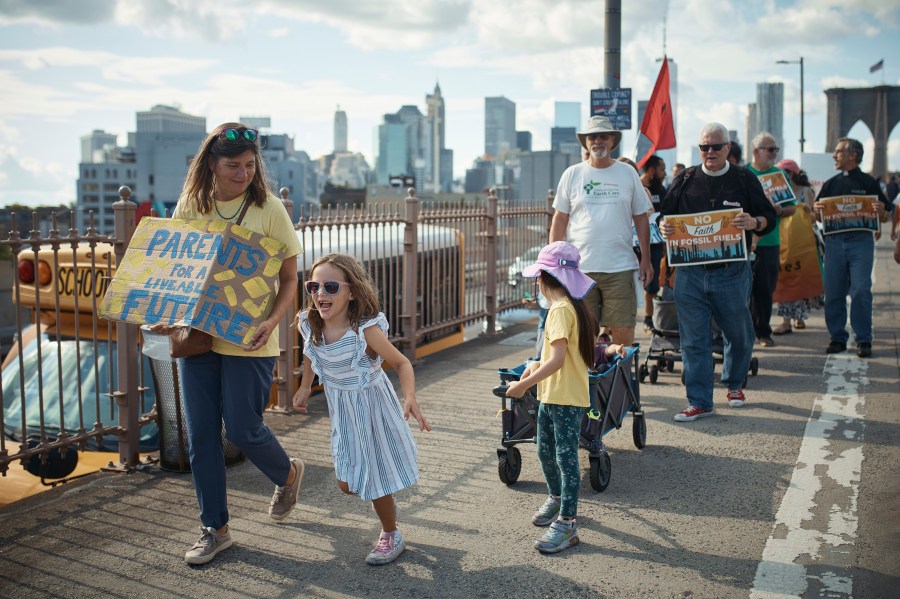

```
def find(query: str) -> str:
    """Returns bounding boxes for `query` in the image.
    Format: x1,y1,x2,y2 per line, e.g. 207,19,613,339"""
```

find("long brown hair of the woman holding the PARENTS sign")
181,123,269,214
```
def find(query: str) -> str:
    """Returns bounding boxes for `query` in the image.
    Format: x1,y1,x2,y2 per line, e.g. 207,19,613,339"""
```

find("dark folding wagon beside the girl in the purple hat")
494,347,647,492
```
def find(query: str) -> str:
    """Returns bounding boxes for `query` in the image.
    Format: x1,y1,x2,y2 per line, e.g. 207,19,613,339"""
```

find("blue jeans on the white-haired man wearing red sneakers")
675,262,754,410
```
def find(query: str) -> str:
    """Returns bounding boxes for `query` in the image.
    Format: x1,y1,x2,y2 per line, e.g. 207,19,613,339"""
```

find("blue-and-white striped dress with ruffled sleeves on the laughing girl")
300,312,419,501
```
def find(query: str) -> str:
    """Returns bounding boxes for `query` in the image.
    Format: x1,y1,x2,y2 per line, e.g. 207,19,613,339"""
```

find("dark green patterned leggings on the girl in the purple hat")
537,403,586,518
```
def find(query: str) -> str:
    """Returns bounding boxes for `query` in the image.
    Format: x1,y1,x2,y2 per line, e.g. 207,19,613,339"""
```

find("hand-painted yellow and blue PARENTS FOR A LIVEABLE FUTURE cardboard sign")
99,218,285,347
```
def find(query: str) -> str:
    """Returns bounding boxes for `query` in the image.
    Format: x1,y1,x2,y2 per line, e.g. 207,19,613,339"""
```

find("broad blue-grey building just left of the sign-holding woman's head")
135,105,206,209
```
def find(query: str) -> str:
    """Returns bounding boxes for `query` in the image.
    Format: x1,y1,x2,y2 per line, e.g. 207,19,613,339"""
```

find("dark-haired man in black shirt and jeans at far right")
813,137,888,358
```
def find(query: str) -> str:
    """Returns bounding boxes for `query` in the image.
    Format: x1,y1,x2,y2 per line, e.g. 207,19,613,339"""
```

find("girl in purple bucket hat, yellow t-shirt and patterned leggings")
506,241,597,553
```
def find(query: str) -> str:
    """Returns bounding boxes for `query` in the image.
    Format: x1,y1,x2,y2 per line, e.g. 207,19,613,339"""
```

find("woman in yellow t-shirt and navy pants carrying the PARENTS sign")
152,123,303,564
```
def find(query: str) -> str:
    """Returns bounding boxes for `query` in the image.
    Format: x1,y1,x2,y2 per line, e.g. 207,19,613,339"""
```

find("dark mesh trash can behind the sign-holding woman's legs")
141,326,244,472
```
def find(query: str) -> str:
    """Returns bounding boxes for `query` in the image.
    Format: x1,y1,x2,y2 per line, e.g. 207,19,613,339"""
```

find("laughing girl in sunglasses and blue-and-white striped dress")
293,254,431,565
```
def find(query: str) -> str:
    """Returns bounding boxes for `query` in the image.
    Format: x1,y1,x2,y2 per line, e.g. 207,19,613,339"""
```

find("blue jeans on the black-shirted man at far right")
825,231,875,343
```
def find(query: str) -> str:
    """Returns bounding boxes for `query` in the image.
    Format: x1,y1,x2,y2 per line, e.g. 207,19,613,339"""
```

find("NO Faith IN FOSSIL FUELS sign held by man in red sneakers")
666,208,747,266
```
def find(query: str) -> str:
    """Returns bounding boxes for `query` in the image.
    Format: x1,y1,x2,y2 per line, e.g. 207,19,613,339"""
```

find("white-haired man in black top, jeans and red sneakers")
660,123,775,422
